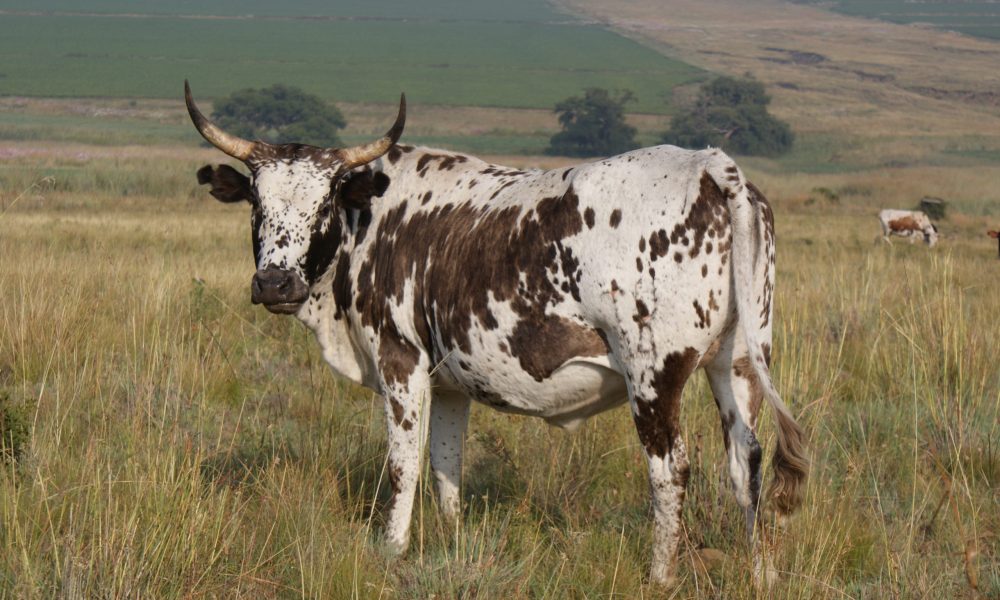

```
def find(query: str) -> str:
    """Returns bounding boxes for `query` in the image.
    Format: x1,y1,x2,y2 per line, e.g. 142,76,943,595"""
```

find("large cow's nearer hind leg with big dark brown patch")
626,348,700,584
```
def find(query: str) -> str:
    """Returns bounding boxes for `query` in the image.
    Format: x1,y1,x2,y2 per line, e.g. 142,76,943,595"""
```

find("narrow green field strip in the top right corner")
798,0,1000,40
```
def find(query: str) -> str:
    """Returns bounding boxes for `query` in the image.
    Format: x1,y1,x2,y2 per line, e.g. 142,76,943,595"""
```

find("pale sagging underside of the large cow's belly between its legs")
436,357,627,430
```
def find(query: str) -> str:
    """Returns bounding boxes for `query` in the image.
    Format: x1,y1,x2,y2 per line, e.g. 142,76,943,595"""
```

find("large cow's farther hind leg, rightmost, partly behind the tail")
705,337,773,580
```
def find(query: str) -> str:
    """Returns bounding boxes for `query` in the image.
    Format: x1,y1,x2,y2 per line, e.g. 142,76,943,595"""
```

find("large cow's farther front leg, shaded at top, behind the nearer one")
430,392,470,524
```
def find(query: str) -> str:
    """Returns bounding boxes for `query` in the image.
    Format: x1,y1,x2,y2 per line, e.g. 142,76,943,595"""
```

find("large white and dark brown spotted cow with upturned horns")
184,82,808,584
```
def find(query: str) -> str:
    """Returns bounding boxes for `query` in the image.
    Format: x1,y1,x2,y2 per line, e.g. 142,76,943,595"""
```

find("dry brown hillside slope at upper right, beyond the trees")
560,0,1000,178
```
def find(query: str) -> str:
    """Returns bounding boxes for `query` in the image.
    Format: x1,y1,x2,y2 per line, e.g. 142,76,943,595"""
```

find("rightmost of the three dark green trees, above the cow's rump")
663,77,795,156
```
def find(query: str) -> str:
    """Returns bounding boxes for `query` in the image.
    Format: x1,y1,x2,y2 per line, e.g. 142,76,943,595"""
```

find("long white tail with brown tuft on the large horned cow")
707,151,809,514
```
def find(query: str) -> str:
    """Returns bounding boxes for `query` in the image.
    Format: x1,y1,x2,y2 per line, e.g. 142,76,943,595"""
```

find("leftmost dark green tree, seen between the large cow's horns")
212,84,347,146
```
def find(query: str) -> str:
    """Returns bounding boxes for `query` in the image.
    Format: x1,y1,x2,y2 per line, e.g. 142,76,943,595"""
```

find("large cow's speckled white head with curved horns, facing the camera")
184,81,406,314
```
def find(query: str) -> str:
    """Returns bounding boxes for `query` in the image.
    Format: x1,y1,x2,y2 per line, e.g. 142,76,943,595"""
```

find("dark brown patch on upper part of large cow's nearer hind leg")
635,347,698,458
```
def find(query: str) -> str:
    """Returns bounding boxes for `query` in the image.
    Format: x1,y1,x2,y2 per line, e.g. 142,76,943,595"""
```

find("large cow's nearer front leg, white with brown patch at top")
379,335,430,555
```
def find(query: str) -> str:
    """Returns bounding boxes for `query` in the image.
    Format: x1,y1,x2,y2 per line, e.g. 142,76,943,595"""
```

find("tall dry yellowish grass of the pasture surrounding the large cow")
0,159,1000,598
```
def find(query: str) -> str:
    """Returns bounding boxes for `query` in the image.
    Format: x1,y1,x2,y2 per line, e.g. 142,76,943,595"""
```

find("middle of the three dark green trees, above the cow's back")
546,88,638,156
